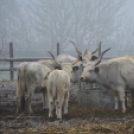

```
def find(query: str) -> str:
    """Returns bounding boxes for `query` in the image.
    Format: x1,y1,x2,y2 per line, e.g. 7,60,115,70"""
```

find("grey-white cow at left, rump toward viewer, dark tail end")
16,60,61,113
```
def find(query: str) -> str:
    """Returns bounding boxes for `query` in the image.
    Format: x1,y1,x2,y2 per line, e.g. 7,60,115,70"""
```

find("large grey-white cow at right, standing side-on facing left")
80,49,134,112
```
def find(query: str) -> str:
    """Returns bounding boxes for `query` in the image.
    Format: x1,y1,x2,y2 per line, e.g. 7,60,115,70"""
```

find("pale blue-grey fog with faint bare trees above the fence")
0,0,134,79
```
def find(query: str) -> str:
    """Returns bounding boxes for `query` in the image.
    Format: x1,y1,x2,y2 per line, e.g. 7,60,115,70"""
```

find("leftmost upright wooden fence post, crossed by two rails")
9,42,14,80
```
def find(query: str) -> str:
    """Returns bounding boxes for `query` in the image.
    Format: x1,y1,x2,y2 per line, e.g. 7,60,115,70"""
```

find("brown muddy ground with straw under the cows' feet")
0,82,134,134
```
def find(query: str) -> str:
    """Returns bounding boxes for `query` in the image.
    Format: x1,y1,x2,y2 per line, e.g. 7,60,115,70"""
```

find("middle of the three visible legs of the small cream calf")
56,96,64,120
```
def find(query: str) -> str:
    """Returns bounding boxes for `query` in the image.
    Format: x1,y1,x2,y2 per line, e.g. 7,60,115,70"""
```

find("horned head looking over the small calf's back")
49,52,79,83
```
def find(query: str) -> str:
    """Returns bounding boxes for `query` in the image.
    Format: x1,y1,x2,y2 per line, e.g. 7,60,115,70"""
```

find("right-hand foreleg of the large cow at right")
117,87,126,112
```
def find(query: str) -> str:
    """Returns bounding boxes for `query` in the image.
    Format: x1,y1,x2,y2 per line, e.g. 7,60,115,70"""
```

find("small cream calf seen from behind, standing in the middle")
44,69,70,120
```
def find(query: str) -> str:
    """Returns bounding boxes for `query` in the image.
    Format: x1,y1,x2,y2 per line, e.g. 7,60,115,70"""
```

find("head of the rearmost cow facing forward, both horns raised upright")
70,41,102,63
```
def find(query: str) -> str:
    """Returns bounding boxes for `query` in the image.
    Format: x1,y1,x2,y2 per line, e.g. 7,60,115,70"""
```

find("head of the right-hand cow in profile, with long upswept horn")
80,48,111,83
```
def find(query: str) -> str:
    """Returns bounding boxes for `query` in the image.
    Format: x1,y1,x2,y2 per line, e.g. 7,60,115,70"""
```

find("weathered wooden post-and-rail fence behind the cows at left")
0,43,60,80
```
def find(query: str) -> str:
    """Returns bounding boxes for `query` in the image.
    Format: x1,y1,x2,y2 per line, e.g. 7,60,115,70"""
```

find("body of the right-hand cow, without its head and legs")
100,56,134,88
